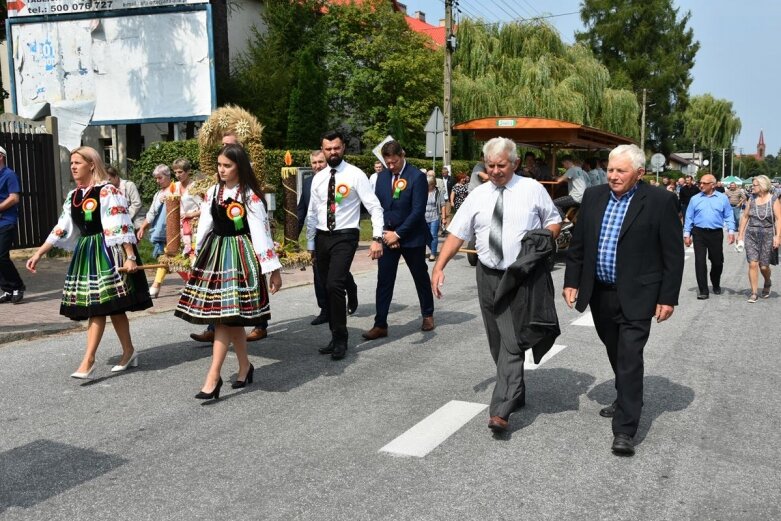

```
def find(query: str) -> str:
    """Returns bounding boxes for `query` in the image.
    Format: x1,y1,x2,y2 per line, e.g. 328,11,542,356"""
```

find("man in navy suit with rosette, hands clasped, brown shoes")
363,141,434,340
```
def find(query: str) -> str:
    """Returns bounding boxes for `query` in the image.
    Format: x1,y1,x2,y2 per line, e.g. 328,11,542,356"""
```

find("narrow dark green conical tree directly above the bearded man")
287,48,328,150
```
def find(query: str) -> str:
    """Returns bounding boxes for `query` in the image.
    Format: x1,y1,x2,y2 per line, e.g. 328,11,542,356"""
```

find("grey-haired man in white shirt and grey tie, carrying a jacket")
431,138,561,432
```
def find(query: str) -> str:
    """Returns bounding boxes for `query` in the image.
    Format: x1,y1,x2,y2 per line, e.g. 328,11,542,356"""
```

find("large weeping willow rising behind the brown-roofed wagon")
453,20,640,138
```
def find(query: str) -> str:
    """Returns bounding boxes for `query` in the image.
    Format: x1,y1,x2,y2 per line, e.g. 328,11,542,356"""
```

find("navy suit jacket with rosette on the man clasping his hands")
374,163,431,248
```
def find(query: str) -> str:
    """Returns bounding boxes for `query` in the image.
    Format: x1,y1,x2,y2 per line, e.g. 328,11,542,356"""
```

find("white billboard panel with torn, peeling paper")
9,6,214,125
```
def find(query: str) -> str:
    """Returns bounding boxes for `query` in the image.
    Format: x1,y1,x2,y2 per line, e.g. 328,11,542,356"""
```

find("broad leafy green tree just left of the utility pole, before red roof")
323,0,444,154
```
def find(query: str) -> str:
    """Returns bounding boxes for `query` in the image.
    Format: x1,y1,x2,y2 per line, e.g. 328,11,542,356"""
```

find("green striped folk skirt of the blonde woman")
60,233,152,320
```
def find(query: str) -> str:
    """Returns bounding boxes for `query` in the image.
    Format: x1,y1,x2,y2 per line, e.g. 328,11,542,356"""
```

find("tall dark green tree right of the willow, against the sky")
576,0,700,154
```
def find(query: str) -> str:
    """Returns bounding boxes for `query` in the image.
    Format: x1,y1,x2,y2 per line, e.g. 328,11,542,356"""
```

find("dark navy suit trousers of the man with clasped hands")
374,245,434,327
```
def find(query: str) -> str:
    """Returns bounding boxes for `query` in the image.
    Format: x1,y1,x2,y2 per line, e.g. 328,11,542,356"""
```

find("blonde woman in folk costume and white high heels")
27,147,152,379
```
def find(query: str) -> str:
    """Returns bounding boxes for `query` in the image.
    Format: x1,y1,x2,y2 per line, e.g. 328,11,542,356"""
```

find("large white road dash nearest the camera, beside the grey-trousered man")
380,400,488,458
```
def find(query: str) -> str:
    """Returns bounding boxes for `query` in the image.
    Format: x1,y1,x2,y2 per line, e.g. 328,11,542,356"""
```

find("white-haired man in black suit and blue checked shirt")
563,145,684,455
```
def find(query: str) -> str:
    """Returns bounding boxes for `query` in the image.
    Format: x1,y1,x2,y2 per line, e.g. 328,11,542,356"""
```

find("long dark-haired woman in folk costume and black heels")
175,145,282,400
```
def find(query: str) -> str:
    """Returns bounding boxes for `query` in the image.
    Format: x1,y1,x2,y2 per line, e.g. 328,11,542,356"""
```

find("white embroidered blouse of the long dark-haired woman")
195,185,282,273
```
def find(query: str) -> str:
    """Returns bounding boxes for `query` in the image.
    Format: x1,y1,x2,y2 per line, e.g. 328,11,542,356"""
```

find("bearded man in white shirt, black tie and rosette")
306,131,383,360
